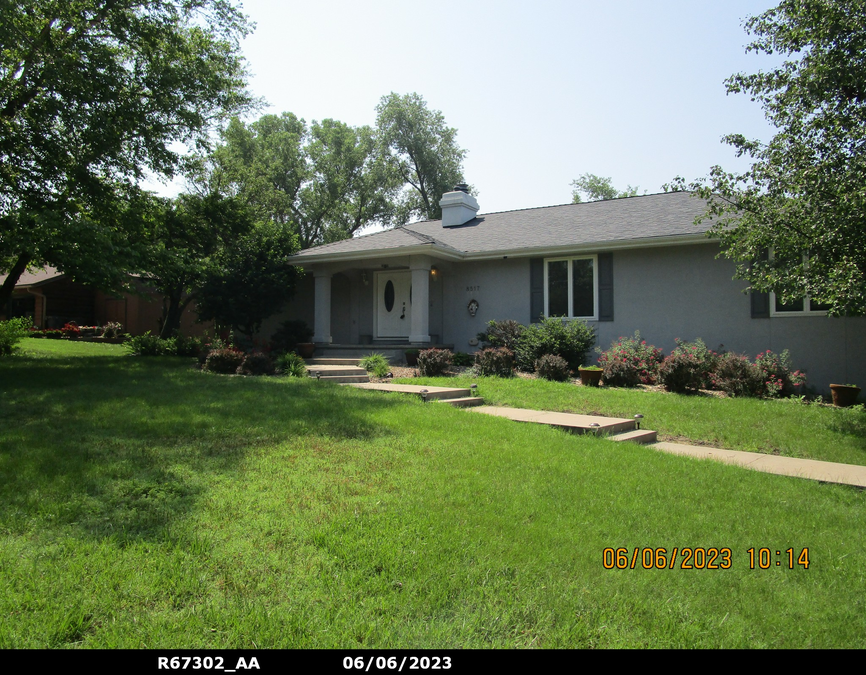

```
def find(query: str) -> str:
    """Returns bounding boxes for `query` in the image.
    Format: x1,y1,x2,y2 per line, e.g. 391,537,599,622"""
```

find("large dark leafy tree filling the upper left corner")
0,0,251,306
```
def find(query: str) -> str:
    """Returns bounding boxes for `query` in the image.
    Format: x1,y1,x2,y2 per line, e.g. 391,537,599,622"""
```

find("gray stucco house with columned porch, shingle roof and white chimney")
280,189,866,391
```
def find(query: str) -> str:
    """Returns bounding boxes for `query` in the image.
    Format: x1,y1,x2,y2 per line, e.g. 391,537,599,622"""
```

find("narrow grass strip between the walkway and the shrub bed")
398,377,866,465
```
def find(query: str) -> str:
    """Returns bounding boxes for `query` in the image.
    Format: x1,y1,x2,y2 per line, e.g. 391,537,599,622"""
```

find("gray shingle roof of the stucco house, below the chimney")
294,192,710,262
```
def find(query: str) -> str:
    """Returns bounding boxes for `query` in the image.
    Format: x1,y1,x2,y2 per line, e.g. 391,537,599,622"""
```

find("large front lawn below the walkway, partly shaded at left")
0,340,866,649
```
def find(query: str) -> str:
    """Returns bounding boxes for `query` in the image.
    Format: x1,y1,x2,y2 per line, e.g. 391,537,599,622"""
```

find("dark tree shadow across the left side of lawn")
0,357,400,544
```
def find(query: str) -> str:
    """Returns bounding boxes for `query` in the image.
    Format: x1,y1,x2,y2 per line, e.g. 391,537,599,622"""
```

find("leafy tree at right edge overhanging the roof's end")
692,0,866,315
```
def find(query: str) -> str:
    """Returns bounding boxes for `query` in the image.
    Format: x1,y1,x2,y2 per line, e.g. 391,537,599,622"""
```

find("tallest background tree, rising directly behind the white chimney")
376,92,466,225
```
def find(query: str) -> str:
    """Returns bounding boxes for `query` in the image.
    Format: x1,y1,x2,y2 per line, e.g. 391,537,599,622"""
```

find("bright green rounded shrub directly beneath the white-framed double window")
515,317,595,373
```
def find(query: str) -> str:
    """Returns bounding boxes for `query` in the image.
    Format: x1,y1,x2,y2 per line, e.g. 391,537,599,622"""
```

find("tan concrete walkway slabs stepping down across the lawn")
348,384,866,488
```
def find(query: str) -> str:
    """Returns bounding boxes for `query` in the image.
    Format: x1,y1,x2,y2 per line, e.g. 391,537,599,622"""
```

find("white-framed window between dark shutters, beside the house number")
544,255,598,321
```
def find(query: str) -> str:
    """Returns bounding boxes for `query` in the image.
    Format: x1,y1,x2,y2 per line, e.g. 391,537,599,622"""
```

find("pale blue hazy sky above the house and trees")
157,0,778,213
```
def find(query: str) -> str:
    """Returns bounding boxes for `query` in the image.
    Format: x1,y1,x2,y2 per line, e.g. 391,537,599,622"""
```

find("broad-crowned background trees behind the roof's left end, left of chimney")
206,113,398,248
